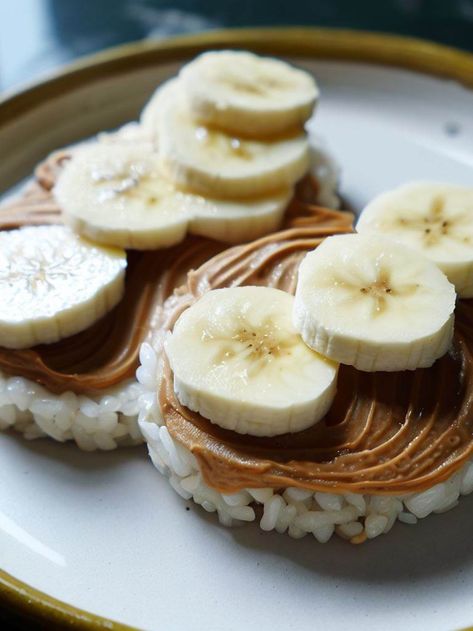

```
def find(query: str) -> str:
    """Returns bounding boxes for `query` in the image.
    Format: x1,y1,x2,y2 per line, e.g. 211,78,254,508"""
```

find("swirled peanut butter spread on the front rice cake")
159,215,473,495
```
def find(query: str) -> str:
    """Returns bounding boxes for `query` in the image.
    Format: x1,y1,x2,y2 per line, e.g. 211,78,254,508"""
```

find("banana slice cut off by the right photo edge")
356,182,473,298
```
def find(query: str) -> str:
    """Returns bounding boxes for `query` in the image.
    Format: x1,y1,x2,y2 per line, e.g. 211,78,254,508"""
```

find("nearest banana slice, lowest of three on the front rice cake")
165,287,338,436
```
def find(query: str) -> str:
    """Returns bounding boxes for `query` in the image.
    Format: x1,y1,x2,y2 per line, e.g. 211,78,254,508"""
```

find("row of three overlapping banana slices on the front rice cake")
165,182,473,436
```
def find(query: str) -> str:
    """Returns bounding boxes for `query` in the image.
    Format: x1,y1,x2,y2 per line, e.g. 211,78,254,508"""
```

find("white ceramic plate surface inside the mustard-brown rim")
0,28,473,631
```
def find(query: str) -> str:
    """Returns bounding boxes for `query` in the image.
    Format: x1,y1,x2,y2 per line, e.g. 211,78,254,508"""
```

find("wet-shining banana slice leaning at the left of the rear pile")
54,143,193,250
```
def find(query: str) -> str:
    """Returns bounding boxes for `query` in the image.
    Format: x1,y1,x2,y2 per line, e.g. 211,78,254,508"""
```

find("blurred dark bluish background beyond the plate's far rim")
0,0,473,91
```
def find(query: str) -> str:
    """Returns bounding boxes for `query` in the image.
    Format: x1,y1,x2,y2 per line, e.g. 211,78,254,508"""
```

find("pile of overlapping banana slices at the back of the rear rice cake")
54,51,318,250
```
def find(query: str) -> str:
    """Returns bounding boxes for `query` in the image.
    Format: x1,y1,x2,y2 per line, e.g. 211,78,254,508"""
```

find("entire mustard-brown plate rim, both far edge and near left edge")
0,27,473,631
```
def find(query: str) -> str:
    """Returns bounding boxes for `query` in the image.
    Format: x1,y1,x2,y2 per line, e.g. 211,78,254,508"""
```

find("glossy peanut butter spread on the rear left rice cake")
0,151,324,394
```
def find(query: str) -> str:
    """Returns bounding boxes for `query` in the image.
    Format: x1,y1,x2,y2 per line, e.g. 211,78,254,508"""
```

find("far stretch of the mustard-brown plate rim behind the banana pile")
0,27,473,137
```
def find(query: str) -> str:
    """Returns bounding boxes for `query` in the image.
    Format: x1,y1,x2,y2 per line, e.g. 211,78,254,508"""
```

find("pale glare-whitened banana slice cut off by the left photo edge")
0,226,126,349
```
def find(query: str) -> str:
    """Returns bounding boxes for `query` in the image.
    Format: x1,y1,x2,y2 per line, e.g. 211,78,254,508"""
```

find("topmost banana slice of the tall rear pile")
179,50,319,137
